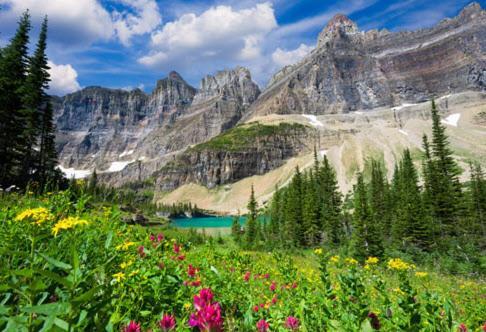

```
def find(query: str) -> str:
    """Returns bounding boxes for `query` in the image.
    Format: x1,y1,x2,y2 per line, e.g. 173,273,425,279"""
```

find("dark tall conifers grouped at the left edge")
0,12,62,189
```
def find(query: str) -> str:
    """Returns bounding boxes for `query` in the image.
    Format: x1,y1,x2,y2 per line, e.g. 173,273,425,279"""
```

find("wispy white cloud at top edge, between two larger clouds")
112,0,162,46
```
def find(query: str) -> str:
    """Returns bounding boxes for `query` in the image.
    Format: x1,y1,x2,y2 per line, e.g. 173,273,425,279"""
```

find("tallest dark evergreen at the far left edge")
0,12,30,187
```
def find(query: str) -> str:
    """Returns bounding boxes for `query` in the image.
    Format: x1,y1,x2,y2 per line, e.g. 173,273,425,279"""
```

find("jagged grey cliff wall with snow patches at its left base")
53,67,260,178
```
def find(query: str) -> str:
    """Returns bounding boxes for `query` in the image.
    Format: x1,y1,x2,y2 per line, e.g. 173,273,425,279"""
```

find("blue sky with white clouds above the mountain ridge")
0,0,486,95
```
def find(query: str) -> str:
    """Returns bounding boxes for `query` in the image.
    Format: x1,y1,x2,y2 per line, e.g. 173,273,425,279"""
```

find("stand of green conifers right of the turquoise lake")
239,102,486,272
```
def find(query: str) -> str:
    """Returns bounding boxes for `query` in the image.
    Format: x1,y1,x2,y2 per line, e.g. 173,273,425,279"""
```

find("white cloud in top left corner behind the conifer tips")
0,0,113,45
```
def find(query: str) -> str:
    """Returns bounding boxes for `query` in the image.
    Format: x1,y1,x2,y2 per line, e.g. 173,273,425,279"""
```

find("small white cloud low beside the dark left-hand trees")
49,61,81,96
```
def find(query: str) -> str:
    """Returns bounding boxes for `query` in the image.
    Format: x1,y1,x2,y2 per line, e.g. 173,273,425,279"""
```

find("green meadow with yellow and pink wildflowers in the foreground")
0,192,486,331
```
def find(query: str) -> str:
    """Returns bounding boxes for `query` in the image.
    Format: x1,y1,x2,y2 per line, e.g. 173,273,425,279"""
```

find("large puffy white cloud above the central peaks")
139,2,277,68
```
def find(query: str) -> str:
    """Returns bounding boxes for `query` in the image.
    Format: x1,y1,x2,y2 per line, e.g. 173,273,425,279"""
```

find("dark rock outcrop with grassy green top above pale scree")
157,123,316,191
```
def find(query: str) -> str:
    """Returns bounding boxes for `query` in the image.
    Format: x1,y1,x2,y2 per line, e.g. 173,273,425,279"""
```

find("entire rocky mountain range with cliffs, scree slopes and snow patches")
52,3,486,214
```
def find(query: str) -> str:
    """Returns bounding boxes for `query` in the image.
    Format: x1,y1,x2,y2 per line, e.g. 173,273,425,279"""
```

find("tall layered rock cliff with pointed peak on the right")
252,4,486,115
